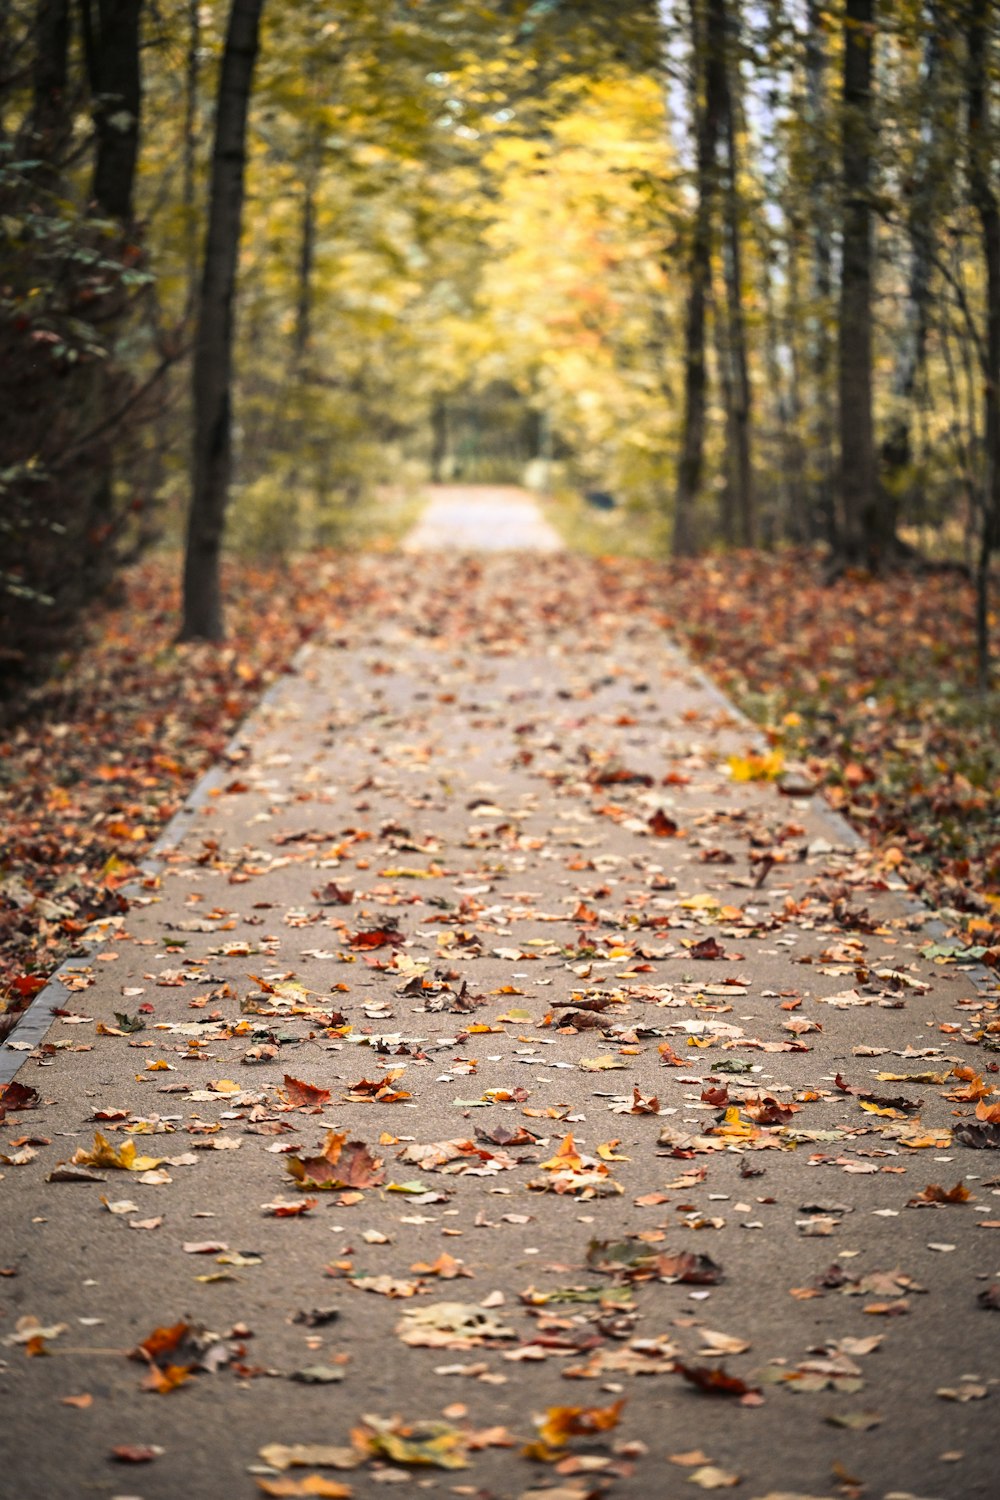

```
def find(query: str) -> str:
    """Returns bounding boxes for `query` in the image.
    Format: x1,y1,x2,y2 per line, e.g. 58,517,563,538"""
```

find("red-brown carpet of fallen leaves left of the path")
0,555,347,1029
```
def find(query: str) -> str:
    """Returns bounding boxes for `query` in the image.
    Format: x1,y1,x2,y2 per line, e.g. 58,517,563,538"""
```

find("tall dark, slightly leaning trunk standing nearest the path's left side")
180,0,264,641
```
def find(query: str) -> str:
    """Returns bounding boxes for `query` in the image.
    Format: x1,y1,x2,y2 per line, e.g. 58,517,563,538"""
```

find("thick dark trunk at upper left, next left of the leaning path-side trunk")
81,0,142,224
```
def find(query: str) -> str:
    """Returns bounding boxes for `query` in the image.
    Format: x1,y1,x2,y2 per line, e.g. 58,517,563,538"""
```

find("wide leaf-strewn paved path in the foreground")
0,557,1000,1500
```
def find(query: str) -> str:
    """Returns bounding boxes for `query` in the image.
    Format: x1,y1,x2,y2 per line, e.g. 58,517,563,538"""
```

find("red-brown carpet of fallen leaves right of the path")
663,551,1000,947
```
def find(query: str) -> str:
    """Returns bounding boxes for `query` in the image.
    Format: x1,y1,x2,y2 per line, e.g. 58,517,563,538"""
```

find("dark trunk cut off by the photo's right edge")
966,0,1000,693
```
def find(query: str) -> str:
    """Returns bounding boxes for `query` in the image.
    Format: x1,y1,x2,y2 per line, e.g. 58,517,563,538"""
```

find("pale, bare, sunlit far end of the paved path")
403,485,562,552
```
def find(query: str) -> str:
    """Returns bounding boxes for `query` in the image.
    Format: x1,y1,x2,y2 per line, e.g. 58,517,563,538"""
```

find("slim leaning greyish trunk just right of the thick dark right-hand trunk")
882,5,945,534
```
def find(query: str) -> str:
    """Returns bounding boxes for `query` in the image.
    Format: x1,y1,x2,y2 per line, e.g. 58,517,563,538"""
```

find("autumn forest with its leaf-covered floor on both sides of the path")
0,0,1000,1011
